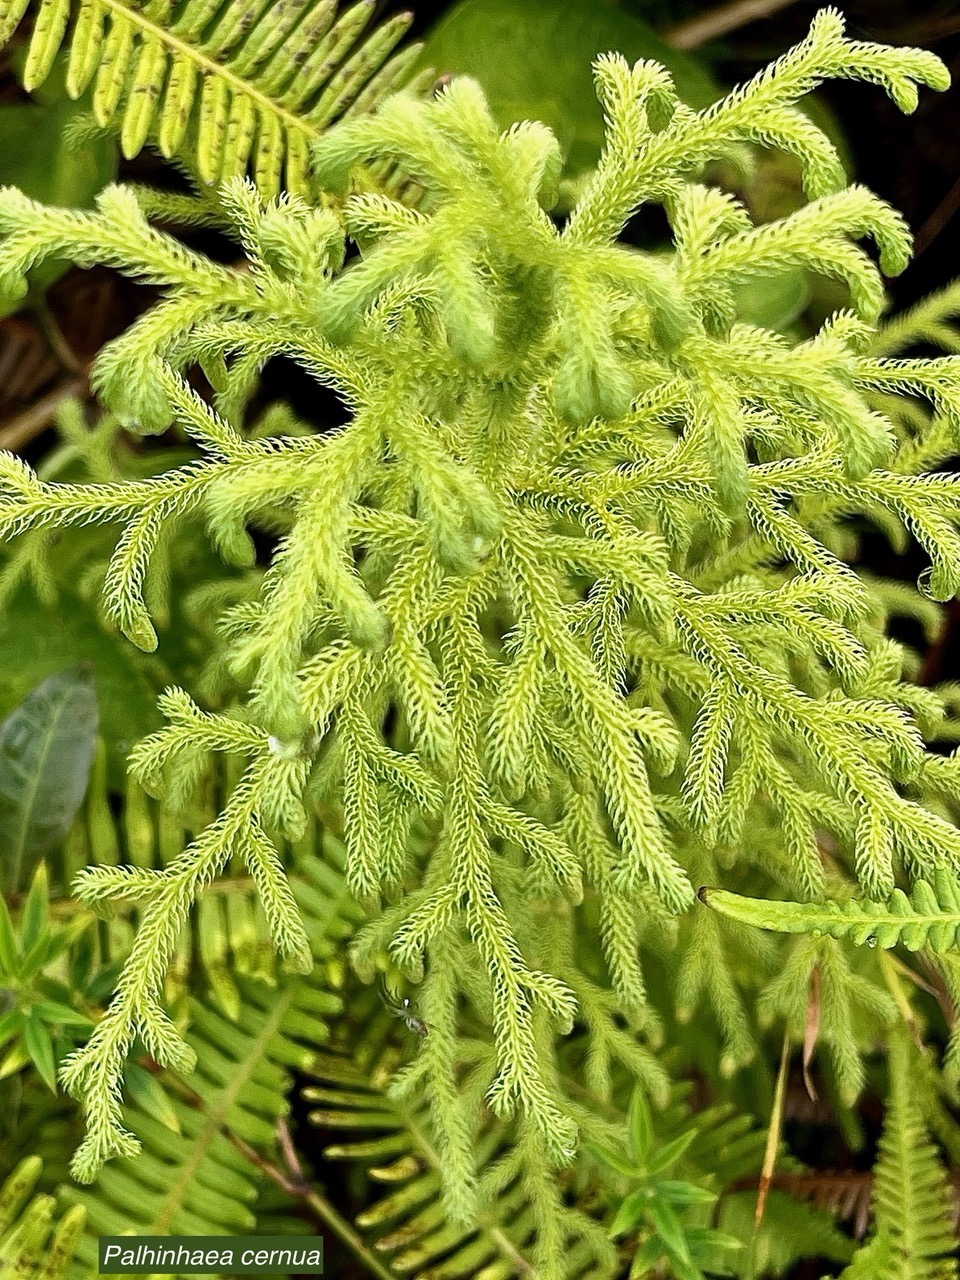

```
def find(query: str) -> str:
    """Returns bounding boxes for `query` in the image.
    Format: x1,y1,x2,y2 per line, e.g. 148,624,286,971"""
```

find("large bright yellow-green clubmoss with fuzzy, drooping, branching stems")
0,6,960,1277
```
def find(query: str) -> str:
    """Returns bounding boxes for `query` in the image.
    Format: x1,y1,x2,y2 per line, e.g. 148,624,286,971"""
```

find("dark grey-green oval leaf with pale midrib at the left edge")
0,667,97,896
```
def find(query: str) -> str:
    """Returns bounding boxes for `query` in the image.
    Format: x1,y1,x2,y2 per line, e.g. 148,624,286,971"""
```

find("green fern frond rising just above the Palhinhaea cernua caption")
0,808,356,1280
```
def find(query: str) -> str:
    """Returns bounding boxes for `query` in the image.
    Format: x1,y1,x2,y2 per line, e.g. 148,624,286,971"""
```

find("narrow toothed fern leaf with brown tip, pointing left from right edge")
700,868,960,951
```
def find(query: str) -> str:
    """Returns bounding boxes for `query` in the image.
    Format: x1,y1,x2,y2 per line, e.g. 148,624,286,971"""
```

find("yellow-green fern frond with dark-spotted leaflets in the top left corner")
0,0,419,197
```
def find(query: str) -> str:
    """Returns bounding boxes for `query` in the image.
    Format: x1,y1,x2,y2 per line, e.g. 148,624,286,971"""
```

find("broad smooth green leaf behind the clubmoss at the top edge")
420,0,718,173
